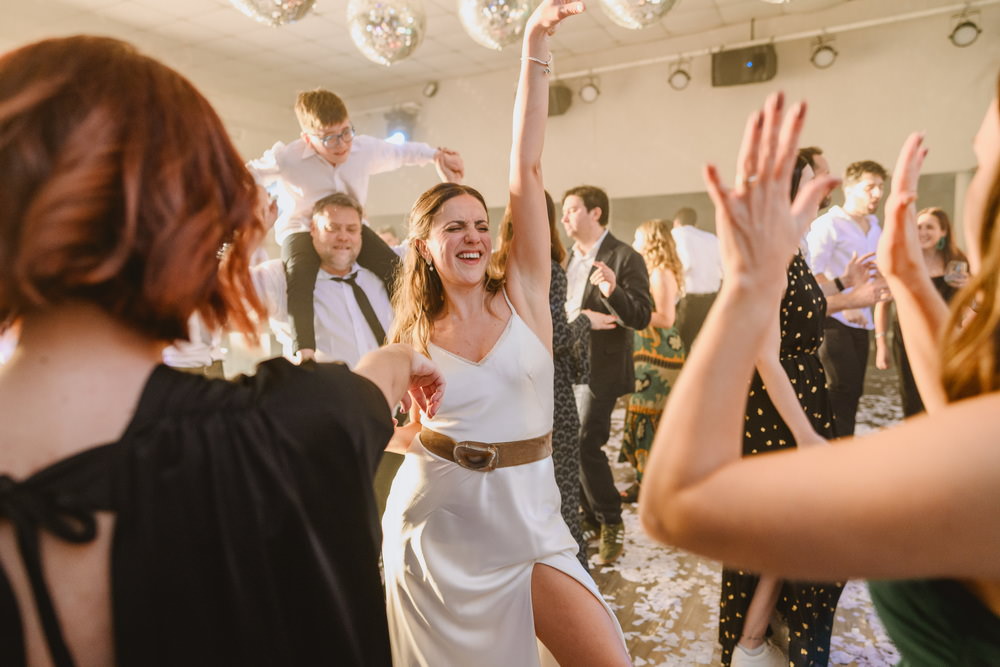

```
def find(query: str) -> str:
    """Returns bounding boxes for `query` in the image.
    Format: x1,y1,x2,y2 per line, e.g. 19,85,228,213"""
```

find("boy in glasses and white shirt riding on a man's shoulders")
247,89,465,361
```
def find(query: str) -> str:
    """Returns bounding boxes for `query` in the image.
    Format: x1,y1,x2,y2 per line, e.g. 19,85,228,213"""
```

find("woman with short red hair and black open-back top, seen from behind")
0,37,442,666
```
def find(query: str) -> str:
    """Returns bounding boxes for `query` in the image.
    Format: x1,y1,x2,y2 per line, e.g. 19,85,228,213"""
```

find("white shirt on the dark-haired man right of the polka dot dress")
806,206,882,329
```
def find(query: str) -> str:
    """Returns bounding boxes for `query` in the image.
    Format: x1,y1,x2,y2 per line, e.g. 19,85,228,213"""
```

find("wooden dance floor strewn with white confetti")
591,376,899,666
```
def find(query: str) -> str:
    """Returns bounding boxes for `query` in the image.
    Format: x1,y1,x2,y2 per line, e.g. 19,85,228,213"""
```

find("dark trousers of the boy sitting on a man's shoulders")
281,225,400,352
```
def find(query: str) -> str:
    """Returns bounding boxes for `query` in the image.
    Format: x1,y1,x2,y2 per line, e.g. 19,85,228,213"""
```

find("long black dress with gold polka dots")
719,254,844,667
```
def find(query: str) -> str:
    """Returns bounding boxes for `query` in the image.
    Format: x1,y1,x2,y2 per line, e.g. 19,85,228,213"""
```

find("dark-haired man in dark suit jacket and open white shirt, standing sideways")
562,185,653,564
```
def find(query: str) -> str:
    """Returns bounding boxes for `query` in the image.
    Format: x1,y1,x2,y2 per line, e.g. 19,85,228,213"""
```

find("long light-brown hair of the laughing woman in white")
389,183,503,354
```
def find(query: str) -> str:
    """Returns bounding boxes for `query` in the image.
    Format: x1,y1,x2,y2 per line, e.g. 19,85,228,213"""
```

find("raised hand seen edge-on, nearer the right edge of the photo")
878,132,927,280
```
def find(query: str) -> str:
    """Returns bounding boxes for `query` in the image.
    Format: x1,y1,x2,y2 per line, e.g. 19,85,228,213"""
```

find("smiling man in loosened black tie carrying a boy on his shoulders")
253,193,392,367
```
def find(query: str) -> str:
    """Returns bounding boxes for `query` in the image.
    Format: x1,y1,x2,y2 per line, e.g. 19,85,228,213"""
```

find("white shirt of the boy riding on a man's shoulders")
247,134,437,245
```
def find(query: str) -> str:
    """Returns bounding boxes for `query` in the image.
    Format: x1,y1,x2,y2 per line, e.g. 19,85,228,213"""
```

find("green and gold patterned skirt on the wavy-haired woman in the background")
621,325,685,484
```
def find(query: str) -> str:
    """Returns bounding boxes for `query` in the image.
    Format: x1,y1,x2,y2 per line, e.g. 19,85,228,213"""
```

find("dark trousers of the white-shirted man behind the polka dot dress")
819,317,868,438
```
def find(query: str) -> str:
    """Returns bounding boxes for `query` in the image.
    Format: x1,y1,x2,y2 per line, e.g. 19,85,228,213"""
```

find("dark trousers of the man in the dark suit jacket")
577,387,622,524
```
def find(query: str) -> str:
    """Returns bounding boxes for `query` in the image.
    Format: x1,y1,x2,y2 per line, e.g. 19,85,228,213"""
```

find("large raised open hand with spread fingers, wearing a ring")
704,93,838,291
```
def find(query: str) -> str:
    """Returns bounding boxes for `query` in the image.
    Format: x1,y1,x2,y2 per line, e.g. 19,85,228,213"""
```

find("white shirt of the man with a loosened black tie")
251,259,392,368
